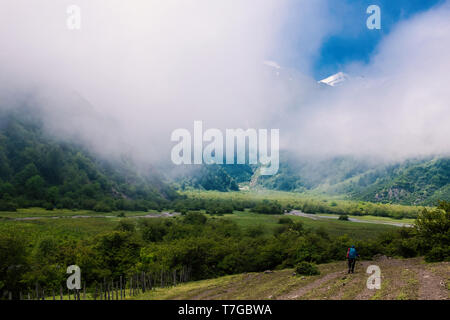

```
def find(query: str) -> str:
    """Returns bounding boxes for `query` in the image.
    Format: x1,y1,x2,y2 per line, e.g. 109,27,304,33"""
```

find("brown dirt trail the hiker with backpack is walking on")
278,256,450,300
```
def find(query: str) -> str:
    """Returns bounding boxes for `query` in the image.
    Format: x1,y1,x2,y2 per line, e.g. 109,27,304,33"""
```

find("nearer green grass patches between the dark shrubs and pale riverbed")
0,208,400,239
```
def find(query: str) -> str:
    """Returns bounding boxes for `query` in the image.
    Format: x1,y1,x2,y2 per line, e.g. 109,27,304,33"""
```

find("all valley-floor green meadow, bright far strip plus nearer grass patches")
0,191,417,239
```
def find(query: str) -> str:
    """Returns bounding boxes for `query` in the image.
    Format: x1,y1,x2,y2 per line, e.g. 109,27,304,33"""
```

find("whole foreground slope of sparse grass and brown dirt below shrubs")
132,257,450,300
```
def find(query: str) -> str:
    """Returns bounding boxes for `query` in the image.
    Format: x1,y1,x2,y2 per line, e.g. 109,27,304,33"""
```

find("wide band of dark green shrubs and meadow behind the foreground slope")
0,203,450,298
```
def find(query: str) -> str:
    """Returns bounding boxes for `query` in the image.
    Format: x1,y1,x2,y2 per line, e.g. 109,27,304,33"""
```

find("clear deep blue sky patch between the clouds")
313,0,445,79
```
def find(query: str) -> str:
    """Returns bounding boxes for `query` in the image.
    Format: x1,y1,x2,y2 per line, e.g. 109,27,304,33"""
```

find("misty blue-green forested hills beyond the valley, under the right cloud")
173,152,450,205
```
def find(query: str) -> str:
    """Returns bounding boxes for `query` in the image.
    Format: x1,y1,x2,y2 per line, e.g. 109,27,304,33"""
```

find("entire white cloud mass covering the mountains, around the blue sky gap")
0,0,450,168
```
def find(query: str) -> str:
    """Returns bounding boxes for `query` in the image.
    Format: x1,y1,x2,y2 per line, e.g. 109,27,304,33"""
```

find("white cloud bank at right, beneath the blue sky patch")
282,2,450,159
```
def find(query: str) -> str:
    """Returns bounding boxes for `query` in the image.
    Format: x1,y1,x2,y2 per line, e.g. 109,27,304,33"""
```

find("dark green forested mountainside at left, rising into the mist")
0,113,177,212
